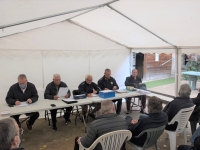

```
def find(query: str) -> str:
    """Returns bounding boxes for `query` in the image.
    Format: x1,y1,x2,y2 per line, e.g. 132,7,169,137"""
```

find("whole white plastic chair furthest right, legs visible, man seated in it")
165,105,195,150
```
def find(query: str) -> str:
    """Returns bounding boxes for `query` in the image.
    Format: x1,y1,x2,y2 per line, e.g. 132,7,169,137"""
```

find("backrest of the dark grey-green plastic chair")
135,125,165,148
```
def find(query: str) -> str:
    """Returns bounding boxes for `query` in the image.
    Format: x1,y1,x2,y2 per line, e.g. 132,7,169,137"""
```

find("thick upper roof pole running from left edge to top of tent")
0,0,118,29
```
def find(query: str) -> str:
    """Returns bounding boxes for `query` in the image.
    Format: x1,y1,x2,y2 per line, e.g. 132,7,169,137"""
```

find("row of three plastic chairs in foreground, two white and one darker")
79,106,195,150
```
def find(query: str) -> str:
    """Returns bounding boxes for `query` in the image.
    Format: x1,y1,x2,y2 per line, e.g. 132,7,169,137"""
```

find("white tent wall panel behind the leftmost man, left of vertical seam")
0,50,43,103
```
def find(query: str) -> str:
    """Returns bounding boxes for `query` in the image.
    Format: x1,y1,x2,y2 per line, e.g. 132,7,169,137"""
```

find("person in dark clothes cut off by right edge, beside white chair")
189,88,200,134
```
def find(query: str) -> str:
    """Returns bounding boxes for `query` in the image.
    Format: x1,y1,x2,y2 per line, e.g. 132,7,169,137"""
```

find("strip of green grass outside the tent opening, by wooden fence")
145,78,175,89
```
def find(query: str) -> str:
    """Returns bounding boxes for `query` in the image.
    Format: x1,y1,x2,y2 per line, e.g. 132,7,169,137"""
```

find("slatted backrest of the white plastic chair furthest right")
168,105,195,133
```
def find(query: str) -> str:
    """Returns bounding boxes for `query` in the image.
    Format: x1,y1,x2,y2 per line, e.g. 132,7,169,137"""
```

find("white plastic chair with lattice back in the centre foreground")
79,130,132,150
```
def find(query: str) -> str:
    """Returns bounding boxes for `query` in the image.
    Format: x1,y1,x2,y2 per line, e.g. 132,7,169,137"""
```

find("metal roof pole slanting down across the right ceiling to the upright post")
107,5,176,48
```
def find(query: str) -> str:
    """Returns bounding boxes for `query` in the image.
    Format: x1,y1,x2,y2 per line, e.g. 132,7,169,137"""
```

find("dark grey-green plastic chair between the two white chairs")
127,125,165,150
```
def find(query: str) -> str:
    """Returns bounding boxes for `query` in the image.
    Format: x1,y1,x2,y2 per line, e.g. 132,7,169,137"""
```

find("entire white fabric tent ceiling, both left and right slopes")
0,0,200,48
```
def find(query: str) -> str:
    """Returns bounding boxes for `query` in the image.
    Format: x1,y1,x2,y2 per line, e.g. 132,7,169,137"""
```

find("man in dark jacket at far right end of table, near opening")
125,69,146,114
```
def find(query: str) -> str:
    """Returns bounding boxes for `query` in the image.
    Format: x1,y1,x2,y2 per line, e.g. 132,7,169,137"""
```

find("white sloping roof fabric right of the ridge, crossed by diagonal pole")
73,0,200,47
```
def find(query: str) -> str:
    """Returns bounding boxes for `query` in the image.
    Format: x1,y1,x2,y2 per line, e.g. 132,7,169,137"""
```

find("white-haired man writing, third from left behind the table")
78,74,101,121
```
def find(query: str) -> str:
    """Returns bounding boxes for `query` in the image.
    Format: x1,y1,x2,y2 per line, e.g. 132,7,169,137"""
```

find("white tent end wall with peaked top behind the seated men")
0,21,130,103
